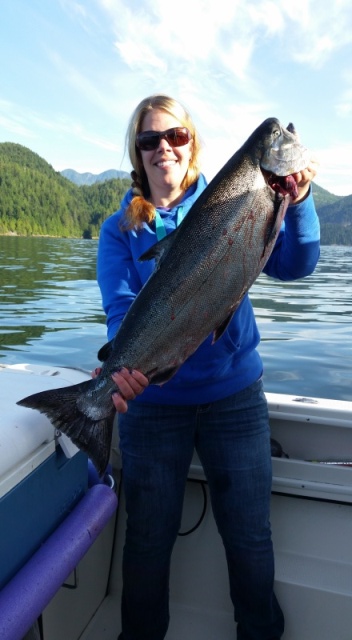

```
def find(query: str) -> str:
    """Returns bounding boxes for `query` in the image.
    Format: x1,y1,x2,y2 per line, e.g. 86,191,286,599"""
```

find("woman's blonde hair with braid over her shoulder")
122,95,201,230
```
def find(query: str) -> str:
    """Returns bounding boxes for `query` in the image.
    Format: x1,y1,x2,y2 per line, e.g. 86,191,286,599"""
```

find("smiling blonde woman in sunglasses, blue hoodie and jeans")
98,96,319,640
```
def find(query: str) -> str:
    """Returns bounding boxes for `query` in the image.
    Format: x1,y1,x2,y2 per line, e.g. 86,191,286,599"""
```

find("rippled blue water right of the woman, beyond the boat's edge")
251,247,352,401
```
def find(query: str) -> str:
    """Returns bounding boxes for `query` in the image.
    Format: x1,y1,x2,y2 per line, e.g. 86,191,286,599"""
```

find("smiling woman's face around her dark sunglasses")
140,109,193,206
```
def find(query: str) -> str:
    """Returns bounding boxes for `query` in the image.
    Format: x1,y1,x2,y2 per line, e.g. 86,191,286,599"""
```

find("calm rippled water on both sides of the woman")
0,236,352,400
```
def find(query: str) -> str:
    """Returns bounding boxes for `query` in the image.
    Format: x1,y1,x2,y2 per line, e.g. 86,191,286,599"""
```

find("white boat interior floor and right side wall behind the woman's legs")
0,364,352,640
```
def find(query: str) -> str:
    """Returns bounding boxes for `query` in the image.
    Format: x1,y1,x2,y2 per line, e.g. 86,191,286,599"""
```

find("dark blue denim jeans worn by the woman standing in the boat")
119,380,284,640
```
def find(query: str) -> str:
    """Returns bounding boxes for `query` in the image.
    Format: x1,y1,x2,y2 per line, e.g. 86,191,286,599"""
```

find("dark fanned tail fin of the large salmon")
17,380,115,476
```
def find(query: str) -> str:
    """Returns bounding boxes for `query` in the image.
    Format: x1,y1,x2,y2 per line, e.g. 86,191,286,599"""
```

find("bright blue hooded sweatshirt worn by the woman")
97,175,320,405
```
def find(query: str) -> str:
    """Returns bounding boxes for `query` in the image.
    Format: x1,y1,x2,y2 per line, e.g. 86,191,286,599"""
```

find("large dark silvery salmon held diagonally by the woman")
18,118,309,474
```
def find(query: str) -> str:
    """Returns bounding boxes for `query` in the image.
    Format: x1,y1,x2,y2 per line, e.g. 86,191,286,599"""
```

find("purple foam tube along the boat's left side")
0,484,117,640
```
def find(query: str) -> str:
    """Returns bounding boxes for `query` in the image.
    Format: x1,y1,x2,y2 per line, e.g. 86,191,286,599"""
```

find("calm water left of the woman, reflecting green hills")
0,236,105,368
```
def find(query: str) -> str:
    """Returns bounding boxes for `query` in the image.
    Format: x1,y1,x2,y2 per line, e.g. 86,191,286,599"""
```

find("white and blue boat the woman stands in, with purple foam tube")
0,364,352,640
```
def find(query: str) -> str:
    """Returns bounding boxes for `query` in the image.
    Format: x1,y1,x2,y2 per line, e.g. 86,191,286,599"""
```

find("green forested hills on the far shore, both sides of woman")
0,142,352,246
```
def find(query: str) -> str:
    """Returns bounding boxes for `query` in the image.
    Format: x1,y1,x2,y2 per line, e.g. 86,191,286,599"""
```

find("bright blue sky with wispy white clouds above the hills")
0,0,352,195
